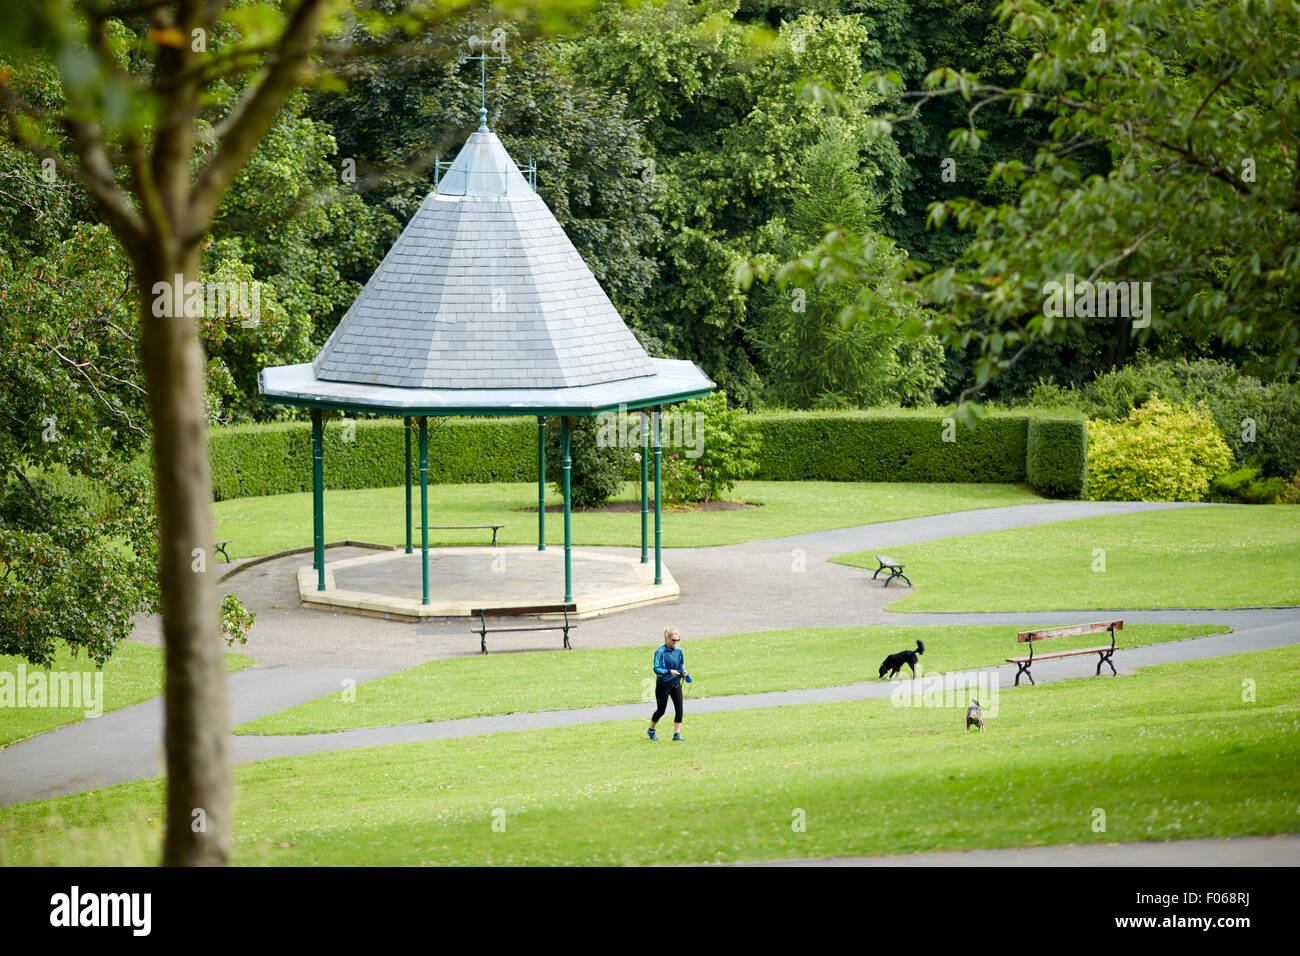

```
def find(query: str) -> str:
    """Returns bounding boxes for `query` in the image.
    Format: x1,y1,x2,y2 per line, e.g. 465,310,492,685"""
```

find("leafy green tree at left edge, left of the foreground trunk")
0,225,156,666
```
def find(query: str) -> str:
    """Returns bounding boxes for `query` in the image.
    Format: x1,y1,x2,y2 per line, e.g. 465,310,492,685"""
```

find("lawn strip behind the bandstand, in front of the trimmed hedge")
215,481,1043,558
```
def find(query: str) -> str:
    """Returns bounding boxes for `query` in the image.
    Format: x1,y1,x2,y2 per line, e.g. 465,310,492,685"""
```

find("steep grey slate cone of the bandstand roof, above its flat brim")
312,125,658,389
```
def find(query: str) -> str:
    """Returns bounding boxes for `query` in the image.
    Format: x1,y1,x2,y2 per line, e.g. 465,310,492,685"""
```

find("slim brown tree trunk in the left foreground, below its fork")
135,250,231,866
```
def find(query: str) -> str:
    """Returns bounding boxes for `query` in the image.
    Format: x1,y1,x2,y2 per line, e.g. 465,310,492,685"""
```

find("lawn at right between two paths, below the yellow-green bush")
833,505,1300,611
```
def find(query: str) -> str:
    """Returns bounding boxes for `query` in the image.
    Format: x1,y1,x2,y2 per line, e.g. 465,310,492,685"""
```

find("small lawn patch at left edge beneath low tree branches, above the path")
0,641,252,747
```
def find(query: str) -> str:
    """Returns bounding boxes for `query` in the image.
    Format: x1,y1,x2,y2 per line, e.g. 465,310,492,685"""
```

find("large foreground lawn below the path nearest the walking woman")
0,646,1300,865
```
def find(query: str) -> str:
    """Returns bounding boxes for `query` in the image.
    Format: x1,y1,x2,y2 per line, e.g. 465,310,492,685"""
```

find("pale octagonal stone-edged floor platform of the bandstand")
298,545,681,620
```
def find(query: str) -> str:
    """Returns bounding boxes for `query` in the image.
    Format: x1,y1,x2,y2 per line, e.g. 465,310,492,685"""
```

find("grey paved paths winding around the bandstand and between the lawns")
0,502,1300,805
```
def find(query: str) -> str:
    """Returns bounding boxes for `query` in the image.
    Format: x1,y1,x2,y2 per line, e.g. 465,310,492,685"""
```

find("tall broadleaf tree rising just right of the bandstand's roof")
569,0,928,406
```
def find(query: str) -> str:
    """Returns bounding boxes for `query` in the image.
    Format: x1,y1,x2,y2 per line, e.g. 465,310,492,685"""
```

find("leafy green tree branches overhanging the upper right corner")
795,0,1300,408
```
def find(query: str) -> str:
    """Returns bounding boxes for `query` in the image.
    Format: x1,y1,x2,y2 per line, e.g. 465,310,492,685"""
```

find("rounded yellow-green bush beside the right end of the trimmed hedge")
1088,393,1232,501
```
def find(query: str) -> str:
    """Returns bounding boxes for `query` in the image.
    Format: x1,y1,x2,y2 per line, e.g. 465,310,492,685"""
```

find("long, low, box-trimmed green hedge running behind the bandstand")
208,408,1088,501
